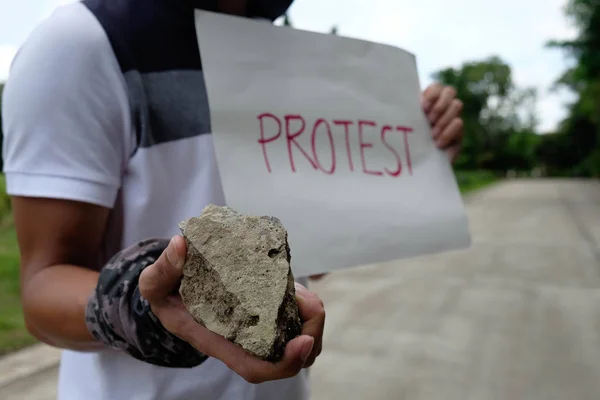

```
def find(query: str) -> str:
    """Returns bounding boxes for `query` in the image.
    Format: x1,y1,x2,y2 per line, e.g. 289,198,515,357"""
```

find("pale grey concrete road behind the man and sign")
0,181,600,400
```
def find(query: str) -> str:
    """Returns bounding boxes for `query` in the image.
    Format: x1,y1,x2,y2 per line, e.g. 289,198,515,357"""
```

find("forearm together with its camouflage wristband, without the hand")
23,239,207,368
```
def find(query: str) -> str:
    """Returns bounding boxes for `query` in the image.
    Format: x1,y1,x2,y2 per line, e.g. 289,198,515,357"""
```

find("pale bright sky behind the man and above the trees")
0,0,575,132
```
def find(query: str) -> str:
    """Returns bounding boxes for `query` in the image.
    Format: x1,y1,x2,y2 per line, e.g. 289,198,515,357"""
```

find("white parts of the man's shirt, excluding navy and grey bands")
2,3,308,400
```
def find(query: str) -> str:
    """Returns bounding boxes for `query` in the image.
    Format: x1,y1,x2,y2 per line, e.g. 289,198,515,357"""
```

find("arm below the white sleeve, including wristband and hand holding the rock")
13,197,325,383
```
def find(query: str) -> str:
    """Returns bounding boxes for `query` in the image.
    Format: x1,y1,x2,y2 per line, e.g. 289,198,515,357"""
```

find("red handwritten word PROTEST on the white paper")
258,113,413,178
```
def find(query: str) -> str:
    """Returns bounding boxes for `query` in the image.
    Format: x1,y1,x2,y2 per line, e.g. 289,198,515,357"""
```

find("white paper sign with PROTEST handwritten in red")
196,11,470,277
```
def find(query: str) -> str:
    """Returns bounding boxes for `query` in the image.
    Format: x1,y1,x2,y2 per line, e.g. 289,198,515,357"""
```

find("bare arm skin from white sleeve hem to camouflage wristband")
13,197,109,351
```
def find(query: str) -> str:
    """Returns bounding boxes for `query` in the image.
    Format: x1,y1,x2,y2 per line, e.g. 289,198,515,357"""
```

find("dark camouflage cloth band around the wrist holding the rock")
86,239,207,368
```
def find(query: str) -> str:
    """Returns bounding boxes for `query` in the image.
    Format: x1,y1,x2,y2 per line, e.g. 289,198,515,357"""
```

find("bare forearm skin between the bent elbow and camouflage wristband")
22,265,105,351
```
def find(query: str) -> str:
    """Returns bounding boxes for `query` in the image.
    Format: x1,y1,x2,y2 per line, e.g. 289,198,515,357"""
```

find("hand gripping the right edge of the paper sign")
421,83,464,161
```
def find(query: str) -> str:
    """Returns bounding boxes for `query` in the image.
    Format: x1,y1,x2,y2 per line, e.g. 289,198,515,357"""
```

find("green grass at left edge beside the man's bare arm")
0,176,36,355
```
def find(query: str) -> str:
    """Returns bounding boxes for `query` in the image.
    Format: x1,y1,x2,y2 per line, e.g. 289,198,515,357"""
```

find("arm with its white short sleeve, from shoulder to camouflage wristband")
2,5,132,350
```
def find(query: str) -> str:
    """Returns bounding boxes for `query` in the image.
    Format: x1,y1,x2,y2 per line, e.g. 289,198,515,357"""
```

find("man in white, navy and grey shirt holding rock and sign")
3,0,462,400
